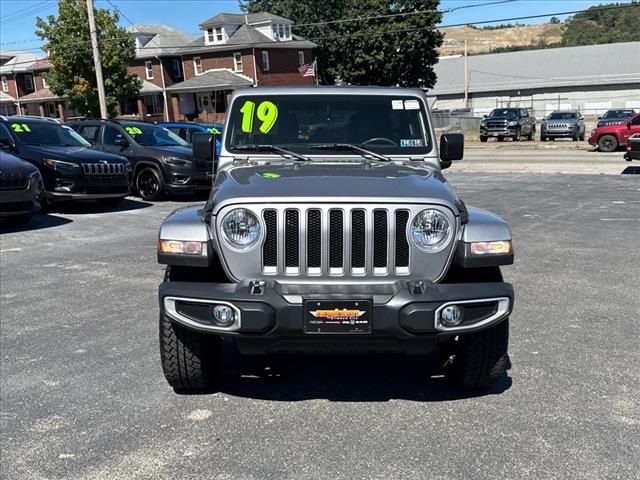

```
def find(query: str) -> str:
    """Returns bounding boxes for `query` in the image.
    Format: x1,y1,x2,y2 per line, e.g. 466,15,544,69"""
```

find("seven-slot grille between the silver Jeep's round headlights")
262,207,409,276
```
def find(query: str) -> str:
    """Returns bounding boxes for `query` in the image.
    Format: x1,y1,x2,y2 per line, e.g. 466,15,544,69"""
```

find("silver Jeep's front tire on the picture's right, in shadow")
445,319,509,390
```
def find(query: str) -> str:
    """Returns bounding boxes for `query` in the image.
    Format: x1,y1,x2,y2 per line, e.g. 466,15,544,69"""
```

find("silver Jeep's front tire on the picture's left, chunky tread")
160,313,222,392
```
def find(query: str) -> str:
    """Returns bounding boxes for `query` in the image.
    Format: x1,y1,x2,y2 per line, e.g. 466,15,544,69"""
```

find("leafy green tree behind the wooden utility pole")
36,0,142,116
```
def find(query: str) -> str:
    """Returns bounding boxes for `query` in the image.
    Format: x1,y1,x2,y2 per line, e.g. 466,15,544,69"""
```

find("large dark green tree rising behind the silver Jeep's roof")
240,0,443,88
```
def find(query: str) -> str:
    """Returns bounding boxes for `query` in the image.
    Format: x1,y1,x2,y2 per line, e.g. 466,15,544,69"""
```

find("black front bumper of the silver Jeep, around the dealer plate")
159,281,514,354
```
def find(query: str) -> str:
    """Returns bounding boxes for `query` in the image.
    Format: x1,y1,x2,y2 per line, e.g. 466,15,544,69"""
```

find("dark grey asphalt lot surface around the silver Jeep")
0,169,640,480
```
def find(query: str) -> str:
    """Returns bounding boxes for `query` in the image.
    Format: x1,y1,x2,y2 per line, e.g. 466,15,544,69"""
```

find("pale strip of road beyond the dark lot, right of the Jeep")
452,148,640,175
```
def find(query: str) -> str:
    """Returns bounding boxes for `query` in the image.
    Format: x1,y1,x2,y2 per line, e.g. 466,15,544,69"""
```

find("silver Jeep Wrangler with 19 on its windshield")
158,87,513,390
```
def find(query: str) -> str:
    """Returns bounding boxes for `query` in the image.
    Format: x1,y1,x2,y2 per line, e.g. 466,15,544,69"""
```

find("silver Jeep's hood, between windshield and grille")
213,162,457,212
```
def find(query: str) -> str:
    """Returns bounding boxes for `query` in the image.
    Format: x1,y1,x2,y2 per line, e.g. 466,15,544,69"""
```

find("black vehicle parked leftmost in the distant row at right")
480,108,536,142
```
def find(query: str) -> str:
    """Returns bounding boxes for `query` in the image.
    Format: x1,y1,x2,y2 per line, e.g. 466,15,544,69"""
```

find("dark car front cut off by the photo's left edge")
0,151,44,223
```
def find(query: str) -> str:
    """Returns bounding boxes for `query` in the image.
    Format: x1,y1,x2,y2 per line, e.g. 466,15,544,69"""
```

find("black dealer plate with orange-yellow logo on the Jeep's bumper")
304,300,371,334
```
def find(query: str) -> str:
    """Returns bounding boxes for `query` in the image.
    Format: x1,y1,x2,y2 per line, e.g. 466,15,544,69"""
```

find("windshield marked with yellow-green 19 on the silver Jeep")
225,94,431,155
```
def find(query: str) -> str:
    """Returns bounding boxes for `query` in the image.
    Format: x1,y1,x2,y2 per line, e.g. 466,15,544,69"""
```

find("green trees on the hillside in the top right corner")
562,2,640,46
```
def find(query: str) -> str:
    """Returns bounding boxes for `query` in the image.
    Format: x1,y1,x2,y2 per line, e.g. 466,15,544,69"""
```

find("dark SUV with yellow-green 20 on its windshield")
67,119,212,200
